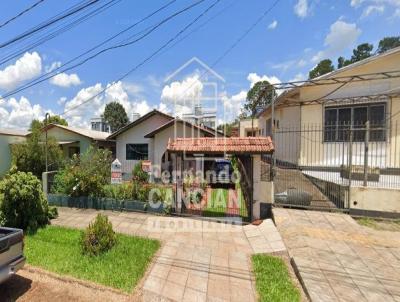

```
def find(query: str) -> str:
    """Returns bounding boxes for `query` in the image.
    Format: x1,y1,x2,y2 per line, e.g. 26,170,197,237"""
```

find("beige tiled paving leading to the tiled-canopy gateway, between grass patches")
52,208,285,302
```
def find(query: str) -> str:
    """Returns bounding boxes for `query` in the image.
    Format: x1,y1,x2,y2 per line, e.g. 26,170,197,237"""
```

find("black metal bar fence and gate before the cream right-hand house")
265,122,400,209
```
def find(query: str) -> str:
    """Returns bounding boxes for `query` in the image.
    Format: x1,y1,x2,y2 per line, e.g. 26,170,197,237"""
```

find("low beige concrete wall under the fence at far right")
350,187,400,213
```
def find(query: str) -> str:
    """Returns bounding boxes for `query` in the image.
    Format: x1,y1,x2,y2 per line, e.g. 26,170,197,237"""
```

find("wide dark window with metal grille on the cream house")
324,104,386,142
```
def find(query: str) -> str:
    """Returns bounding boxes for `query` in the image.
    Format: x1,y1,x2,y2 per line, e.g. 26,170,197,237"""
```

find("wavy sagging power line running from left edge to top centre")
0,0,205,99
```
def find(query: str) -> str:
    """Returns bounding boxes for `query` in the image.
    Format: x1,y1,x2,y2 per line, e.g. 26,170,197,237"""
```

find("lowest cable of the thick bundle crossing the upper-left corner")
0,0,122,65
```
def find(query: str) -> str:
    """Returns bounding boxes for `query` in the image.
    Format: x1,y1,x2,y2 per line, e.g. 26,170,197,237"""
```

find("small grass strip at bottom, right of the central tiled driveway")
252,255,301,302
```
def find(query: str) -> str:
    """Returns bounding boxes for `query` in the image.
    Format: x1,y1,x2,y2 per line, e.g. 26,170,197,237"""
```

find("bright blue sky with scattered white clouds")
0,0,400,128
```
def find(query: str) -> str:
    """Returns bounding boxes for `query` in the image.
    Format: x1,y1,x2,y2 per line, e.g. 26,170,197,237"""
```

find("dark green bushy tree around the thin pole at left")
11,127,64,179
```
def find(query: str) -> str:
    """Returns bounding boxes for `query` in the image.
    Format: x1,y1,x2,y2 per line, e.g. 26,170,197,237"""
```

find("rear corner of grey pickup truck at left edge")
0,228,25,283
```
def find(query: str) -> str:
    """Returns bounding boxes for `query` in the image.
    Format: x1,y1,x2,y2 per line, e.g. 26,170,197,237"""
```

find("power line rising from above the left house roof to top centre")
61,0,221,116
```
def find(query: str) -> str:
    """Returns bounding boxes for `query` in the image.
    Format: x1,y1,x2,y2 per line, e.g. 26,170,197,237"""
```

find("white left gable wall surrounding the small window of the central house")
116,114,170,174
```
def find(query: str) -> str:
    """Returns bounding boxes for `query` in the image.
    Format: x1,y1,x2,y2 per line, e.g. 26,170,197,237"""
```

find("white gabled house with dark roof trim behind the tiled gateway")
109,110,223,178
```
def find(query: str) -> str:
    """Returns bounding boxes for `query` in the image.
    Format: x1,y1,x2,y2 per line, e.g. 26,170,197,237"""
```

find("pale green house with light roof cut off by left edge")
0,129,28,177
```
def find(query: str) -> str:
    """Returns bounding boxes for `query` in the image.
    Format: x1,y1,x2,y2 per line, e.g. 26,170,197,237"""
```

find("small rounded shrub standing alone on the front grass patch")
81,214,117,256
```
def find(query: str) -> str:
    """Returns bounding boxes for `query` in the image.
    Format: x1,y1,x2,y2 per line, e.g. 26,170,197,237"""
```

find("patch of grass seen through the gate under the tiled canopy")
203,188,248,217
